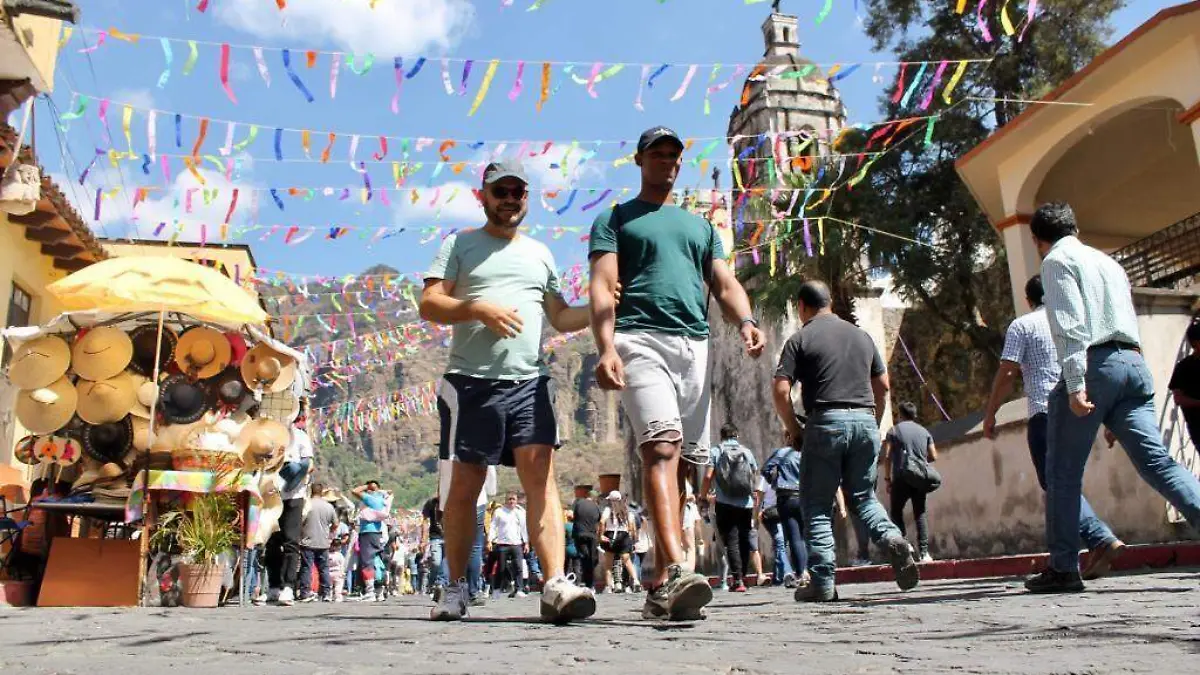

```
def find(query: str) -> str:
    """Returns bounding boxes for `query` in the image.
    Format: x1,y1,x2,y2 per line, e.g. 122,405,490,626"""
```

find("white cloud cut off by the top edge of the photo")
215,0,475,56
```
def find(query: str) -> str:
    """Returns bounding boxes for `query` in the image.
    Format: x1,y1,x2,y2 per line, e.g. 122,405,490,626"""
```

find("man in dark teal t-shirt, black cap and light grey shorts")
589,126,763,620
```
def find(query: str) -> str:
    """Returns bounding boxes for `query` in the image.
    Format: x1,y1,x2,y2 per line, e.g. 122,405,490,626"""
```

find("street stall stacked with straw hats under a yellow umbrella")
4,258,307,604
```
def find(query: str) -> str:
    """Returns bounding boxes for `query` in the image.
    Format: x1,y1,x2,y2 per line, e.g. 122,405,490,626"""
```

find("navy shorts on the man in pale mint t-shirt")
438,374,558,466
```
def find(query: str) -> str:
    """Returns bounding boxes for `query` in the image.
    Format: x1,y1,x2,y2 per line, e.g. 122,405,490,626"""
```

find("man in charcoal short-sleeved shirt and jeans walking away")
774,281,919,602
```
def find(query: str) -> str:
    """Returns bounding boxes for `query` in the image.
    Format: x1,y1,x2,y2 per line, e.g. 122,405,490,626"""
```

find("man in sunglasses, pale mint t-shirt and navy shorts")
420,163,595,622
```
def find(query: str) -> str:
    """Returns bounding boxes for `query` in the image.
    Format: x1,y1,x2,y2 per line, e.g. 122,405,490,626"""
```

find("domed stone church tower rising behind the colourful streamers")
727,10,846,197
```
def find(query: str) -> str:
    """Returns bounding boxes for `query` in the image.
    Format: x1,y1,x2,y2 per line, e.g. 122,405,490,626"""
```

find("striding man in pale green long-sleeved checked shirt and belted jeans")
1025,202,1200,593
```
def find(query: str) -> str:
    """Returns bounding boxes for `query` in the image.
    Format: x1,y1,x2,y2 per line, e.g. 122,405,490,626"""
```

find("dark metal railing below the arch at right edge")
1112,214,1200,289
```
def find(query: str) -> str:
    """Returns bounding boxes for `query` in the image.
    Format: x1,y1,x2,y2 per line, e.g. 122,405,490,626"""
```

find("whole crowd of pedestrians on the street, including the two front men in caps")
248,126,1200,622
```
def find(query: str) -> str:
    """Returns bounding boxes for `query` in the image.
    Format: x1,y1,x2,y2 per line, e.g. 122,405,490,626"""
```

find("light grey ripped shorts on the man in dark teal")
614,331,712,455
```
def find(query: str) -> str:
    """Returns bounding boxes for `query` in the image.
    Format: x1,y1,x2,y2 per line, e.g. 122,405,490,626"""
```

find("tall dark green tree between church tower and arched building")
851,0,1124,362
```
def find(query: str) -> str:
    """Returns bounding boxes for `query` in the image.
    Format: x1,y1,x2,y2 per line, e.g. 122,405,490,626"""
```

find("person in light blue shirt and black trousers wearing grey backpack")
700,423,758,593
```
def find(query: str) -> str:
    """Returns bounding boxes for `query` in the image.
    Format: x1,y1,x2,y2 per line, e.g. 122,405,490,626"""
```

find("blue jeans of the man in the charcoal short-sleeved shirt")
800,410,900,591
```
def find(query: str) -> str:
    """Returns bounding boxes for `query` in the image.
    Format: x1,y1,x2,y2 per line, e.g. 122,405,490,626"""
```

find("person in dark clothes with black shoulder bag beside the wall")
883,401,937,562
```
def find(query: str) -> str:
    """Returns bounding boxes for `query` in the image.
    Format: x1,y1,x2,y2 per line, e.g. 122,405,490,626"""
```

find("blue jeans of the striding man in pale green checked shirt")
1046,346,1200,572
